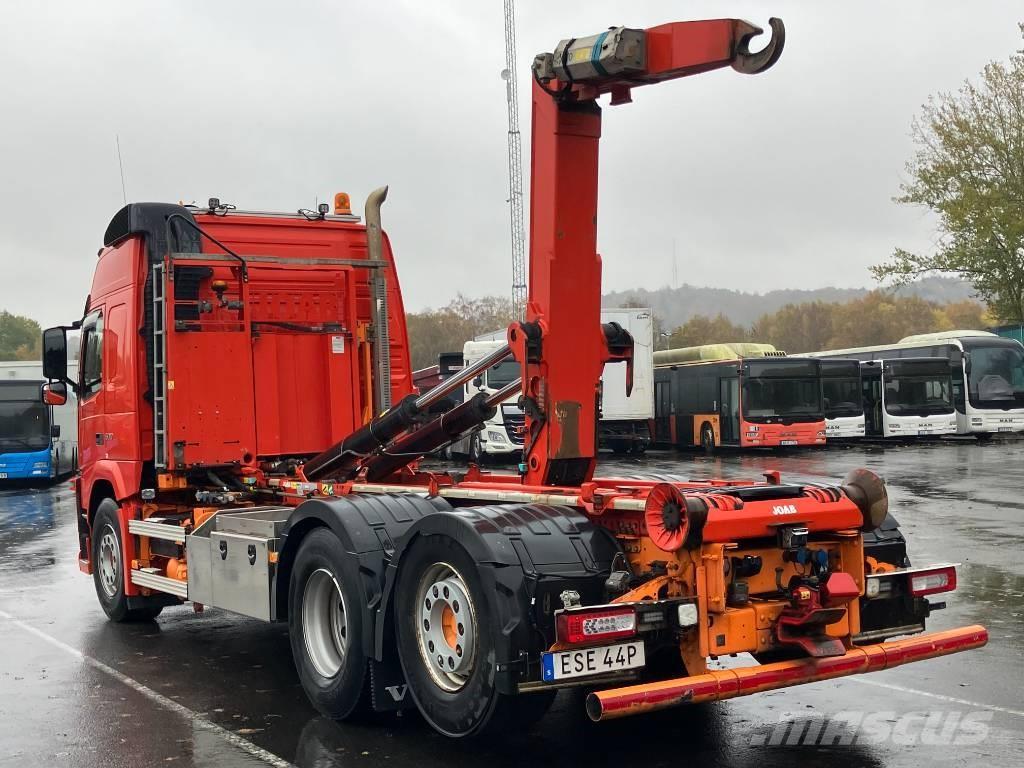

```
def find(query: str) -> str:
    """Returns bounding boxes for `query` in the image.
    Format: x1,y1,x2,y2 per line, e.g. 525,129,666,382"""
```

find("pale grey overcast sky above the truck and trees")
0,0,1024,326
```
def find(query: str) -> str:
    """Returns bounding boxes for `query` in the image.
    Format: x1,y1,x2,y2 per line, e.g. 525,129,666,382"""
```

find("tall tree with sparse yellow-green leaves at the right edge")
871,25,1024,323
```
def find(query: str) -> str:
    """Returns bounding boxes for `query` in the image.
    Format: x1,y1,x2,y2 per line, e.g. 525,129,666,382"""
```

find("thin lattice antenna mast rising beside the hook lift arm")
502,0,526,319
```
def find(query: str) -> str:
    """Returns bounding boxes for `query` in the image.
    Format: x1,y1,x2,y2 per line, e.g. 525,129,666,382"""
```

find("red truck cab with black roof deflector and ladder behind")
61,201,413,577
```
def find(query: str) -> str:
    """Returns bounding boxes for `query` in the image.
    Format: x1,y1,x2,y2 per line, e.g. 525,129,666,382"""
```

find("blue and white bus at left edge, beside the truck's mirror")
0,362,78,482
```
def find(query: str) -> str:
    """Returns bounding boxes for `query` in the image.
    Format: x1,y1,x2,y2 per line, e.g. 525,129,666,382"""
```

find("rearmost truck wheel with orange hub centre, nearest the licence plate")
395,536,554,737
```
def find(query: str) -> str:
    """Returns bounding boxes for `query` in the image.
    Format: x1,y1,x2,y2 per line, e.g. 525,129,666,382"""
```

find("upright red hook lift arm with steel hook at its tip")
508,18,785,486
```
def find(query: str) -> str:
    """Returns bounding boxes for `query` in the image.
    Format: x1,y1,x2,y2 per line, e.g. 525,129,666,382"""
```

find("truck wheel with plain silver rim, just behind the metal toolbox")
288,528,369,720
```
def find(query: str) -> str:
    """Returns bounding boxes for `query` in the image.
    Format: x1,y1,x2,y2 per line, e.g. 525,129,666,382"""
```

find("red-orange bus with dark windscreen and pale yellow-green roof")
654,344,825,453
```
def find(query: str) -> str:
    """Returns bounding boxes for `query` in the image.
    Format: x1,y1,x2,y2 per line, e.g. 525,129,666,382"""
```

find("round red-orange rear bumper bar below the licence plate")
587,625,988,721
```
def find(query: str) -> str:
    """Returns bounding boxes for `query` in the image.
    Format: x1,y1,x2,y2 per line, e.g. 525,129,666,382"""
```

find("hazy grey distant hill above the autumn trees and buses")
603,278,974,329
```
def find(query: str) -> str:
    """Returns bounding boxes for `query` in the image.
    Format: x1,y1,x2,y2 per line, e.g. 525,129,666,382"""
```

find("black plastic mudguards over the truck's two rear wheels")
273,494,622,709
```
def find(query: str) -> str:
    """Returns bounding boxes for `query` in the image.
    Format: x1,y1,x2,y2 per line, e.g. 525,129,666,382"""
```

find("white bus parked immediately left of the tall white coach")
860,357,956,437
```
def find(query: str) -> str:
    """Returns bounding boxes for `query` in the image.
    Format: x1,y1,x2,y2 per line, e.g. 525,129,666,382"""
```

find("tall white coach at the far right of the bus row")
808,331,1024,437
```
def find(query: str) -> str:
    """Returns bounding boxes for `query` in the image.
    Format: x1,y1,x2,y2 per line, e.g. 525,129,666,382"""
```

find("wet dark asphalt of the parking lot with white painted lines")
0,440,1024,768
